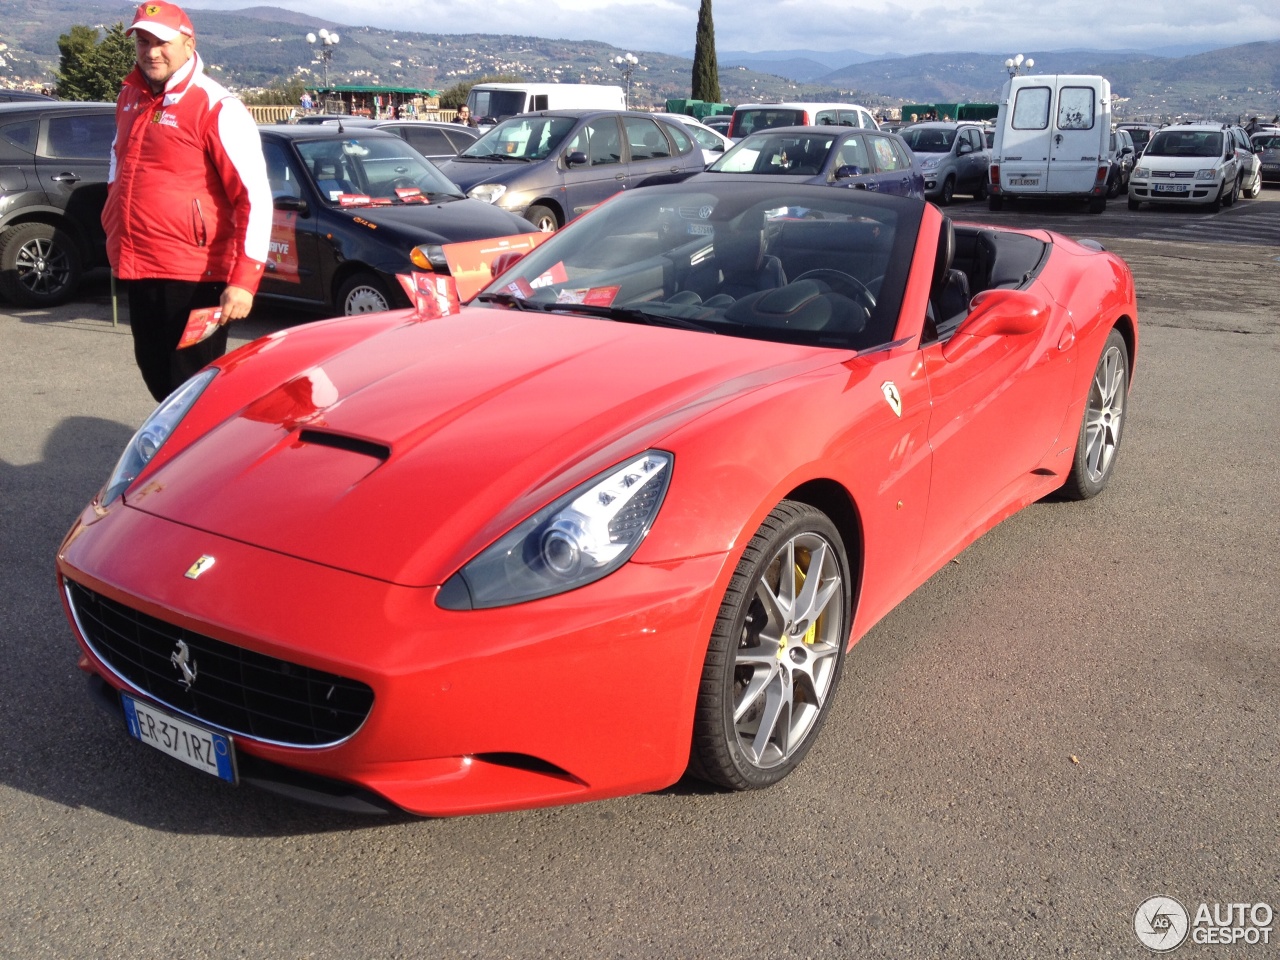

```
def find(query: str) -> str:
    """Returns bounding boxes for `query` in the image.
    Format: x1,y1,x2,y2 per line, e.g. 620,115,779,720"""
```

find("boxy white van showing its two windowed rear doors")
988,74,1111,214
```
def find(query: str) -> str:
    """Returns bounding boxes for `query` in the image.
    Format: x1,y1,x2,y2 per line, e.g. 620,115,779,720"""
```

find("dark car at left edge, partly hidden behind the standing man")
0,100,115,307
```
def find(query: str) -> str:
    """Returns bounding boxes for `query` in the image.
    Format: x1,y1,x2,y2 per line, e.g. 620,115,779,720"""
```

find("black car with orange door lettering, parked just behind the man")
259,124,532,314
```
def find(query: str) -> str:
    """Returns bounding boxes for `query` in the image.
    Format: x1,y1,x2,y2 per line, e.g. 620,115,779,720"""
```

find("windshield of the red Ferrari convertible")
479,180,924,349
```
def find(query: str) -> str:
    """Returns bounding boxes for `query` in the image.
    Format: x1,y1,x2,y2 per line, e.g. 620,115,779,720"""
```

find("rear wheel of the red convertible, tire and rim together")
1062,329,1129,500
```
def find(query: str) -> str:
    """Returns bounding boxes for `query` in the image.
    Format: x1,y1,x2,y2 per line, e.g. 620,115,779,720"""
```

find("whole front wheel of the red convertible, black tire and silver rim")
689,500,852,790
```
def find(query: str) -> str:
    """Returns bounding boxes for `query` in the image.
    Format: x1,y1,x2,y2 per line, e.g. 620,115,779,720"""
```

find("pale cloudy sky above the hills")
197,0,1280,55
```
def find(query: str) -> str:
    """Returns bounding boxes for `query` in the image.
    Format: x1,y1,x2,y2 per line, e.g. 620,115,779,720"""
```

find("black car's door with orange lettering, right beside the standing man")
261,140,322,303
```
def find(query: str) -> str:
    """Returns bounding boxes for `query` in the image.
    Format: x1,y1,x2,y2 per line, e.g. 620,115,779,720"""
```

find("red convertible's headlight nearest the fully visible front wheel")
436,451,672,611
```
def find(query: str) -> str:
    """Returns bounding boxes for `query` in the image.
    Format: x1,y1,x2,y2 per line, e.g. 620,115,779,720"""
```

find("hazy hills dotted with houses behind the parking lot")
0,0,1280,119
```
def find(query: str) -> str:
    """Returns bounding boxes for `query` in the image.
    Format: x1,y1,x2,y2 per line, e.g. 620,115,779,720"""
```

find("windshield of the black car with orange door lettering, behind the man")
297,134,463,206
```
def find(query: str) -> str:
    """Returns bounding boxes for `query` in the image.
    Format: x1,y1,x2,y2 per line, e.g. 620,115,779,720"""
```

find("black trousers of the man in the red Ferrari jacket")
128,280,227,402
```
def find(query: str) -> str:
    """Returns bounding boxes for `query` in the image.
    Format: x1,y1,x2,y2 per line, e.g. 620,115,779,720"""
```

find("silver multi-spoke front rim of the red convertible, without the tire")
733,531,847,769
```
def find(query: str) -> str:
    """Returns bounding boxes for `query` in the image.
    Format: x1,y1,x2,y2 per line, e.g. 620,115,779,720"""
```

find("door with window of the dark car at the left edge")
36,108,115,265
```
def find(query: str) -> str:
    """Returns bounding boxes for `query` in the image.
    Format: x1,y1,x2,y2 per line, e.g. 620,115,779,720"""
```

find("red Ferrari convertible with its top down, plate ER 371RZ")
58,182,1138,815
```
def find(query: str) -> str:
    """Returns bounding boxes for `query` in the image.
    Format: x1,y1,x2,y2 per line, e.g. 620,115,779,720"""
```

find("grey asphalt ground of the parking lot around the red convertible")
0,188,1280,960
